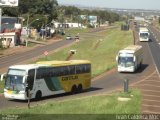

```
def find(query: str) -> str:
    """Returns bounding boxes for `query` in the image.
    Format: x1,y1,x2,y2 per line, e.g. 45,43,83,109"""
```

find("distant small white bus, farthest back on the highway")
139,27,150,42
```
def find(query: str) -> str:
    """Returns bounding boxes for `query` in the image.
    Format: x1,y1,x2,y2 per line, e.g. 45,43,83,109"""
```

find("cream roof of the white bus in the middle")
120,45,142,53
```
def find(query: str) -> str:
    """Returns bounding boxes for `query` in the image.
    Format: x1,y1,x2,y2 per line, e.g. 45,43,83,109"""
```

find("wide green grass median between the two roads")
37,28,133,77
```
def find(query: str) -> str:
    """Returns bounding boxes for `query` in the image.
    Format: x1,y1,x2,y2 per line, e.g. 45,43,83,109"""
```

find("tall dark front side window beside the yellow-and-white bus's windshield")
27,69,35,90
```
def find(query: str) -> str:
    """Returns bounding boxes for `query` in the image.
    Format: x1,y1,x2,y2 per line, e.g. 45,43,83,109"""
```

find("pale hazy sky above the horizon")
57,0,160,10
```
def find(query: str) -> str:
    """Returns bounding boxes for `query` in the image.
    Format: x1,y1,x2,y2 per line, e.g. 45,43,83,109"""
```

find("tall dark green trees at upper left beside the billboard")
3,0,58,21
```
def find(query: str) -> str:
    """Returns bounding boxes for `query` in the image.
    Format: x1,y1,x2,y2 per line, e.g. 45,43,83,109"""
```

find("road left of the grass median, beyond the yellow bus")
0,40,73,73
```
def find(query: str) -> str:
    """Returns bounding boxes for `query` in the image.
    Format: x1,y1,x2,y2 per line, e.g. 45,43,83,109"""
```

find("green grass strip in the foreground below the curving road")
0,90,141,120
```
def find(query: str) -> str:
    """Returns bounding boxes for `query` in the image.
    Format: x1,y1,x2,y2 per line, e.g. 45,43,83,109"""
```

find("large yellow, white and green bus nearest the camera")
4,60,91,100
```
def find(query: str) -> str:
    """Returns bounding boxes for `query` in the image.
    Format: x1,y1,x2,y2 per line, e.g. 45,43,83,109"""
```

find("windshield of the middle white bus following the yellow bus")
118,57,134,67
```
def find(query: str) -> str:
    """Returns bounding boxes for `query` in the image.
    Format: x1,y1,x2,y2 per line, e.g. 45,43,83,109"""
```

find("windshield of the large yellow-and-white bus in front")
5,69,26,91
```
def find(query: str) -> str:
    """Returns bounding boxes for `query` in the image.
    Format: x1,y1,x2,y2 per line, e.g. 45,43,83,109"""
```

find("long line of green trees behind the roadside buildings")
2,0,120,27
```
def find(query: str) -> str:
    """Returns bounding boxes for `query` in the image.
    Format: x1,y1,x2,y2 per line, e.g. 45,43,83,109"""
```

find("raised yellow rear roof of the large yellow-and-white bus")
36,60,90,66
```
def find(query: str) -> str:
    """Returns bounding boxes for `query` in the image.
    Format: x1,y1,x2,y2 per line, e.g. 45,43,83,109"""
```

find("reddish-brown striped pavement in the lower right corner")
133,71,160,114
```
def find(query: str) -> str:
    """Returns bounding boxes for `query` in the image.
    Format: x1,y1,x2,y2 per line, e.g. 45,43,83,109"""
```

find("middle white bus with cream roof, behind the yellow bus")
116,45,143,72
